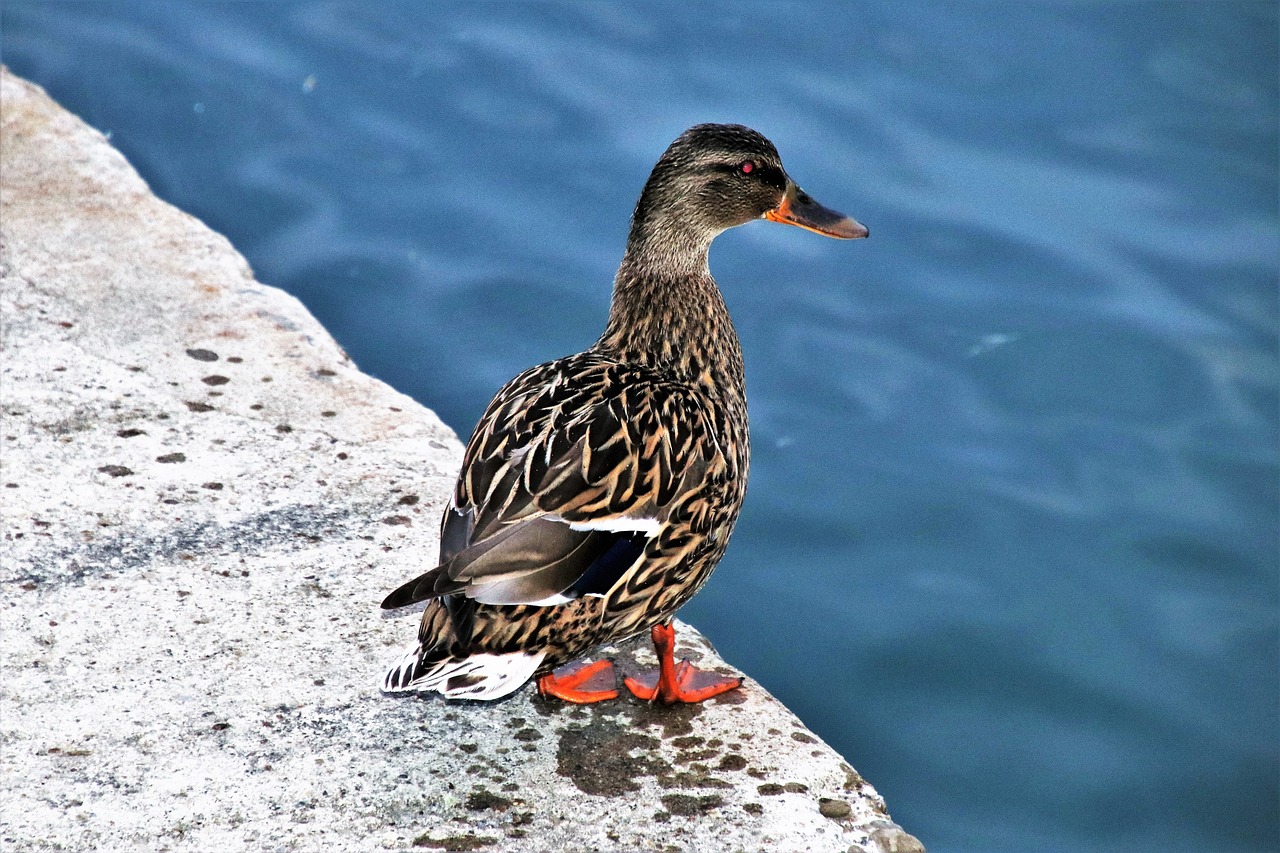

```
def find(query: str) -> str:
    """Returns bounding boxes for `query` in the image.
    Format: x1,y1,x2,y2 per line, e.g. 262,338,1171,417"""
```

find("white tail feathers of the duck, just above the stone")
383,647,547,701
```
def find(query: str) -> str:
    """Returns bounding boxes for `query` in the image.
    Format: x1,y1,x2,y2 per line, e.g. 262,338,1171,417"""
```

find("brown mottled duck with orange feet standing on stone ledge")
373,124,867,704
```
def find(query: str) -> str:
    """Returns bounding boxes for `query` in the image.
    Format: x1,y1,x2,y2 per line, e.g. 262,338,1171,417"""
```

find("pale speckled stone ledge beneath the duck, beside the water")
0,72,920,853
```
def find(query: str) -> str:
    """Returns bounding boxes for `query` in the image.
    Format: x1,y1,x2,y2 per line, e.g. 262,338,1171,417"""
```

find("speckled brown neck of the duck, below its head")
595,222,745,401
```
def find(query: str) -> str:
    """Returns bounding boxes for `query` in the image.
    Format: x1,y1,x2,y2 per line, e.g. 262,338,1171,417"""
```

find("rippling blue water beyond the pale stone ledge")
0,0,1280,850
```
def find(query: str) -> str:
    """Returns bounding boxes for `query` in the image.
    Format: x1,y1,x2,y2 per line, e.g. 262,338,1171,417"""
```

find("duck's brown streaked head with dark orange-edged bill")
631,124,868,261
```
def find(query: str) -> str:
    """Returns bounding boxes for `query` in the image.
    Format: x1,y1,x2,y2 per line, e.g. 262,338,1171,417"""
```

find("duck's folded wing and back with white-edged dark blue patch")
383,352,719,610
